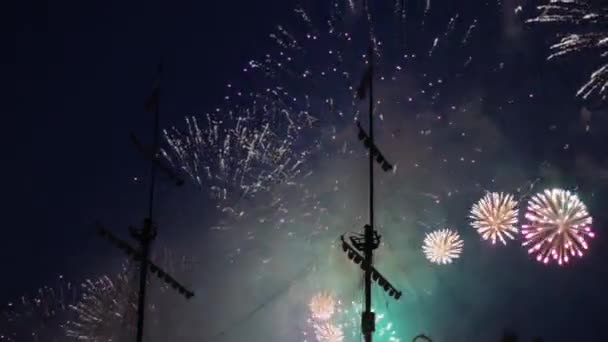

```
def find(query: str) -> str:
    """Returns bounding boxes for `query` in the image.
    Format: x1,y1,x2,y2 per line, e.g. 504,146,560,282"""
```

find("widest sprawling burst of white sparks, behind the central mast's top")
163,0,480,239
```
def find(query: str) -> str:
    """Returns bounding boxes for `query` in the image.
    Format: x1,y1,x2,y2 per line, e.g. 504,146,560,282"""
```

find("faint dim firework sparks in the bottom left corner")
0,276,80,342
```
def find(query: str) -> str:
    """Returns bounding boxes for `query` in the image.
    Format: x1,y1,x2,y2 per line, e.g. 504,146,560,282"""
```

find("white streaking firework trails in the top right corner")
528,0,608,101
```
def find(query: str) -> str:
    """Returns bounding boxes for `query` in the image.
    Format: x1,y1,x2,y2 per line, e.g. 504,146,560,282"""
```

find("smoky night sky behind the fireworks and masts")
5,0,608,341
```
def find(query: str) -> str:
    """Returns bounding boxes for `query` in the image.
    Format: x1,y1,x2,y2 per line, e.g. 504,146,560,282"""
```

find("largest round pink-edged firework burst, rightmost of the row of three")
521,189,595,265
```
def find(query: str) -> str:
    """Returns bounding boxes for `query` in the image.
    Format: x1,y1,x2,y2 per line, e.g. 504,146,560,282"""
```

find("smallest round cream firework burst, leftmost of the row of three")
422,229,464,265
